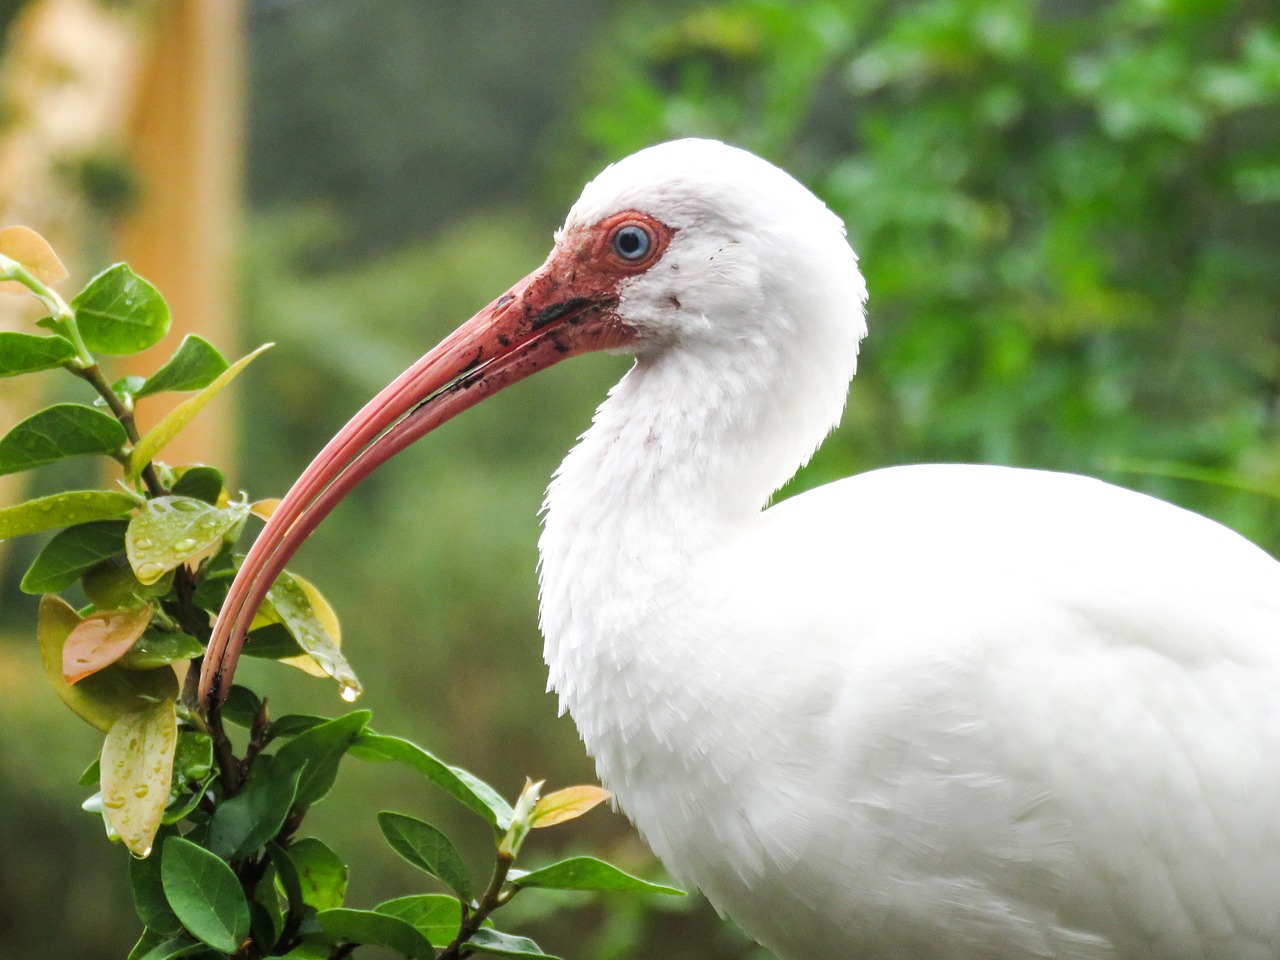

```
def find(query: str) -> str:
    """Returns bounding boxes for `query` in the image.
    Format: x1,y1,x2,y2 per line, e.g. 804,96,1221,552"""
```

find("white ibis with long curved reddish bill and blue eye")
202,140,1280,960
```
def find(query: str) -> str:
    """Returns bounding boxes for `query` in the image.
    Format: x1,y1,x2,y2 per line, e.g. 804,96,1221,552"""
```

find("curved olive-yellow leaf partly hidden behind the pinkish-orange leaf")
36,596,178,737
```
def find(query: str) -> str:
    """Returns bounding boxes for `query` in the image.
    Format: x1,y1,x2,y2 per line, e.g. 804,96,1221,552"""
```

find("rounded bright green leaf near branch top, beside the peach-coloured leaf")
72,264,169,353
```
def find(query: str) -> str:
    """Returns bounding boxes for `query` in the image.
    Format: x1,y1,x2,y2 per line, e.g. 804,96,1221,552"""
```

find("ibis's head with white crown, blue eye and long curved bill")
201,140,865,700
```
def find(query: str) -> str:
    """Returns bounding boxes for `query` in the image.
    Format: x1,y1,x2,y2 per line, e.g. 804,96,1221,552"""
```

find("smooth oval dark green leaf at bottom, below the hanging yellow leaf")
160,837,248,954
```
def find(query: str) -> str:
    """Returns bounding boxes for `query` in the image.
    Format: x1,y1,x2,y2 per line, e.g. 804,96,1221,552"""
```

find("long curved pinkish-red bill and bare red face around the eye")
200,210,675,705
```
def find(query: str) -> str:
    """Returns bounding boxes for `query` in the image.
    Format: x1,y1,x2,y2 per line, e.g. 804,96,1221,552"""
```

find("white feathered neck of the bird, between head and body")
539,335,847,727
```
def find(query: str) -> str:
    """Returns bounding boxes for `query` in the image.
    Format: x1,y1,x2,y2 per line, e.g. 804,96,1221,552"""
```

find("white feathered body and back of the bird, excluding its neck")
602,466,1280,960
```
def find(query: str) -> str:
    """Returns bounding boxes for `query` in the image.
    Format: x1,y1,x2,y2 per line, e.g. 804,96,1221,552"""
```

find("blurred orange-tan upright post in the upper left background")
122,0,243,470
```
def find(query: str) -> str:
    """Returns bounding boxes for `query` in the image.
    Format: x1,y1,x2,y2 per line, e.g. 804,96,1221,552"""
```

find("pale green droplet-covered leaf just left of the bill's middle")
124,497,248,585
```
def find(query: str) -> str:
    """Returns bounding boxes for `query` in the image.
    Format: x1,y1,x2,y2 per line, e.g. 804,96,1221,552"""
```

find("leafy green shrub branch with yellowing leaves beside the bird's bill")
0,227,680,960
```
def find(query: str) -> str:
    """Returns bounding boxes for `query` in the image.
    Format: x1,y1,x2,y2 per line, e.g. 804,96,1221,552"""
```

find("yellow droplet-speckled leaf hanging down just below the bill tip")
101,699,178,856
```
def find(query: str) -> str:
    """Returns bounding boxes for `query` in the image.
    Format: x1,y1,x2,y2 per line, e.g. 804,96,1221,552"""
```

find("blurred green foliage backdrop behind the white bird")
0,0,1280,960
